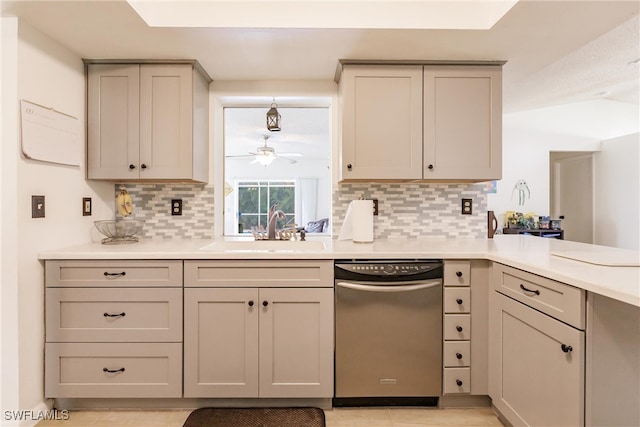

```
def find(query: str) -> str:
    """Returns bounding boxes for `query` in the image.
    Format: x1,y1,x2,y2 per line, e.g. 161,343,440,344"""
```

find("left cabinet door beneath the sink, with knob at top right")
184,288,262,397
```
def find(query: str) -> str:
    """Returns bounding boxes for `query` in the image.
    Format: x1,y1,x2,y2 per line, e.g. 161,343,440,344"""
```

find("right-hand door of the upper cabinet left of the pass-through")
140,64,193,179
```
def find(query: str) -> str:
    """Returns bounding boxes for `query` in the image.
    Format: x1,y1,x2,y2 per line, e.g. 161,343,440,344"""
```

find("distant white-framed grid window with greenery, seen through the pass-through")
237,180,296,233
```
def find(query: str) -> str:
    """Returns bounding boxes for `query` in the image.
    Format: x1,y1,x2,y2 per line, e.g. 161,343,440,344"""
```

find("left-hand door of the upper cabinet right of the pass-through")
341,66,422,180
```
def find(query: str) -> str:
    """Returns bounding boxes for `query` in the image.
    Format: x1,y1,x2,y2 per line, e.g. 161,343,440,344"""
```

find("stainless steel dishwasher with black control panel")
333,260,443,406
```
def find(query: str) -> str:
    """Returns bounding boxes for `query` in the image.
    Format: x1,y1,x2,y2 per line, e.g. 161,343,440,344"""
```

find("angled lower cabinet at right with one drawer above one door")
489,264,585,426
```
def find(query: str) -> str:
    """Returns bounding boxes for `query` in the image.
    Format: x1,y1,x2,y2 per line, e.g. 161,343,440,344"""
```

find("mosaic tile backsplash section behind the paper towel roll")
332,183,487,238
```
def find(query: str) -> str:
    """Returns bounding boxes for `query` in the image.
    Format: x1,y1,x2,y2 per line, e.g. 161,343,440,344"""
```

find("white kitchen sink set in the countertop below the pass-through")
200,240,326,252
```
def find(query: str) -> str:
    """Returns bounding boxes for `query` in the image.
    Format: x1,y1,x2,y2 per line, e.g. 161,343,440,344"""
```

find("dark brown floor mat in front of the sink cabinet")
183,408,325,427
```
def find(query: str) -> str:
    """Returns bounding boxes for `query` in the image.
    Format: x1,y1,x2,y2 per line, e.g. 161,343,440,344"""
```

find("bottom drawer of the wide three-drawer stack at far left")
45,343,182,398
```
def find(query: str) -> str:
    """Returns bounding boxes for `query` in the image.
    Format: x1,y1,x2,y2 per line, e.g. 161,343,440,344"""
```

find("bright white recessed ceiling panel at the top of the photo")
127,0,518,30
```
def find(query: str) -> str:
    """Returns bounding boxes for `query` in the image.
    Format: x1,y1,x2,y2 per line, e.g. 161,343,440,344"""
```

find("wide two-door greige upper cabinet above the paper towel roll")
339,63,502,182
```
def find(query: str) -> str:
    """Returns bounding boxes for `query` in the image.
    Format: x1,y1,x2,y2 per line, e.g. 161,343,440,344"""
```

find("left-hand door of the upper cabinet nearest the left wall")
87,64,140,179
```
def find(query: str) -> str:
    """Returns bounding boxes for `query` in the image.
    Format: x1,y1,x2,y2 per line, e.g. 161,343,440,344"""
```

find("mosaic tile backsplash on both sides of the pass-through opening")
115,183,487,239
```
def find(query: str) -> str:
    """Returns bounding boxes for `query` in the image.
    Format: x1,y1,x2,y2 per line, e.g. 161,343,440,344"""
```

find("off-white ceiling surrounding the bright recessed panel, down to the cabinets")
1,0,640,112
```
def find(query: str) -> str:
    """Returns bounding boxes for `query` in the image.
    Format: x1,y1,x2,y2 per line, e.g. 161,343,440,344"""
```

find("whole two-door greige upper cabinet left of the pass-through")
87,63,209,182
